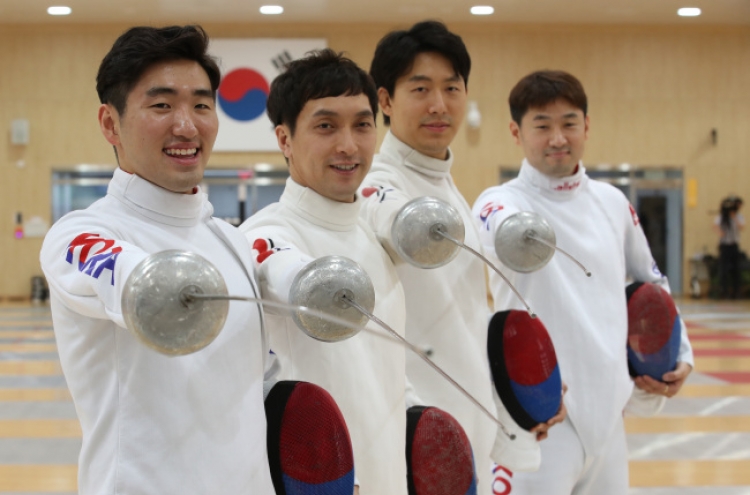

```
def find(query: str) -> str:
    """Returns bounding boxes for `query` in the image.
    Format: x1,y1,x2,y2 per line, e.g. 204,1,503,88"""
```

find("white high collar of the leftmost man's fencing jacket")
107,168,207,227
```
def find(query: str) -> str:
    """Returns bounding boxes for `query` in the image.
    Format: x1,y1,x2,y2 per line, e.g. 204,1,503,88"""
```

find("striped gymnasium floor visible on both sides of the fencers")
0,300,750,495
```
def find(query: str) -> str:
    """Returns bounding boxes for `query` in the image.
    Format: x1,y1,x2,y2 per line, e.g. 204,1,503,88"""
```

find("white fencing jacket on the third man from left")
360,131,497,493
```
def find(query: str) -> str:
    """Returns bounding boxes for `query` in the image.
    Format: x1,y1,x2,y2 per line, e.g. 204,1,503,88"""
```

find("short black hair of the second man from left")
266,48,378,135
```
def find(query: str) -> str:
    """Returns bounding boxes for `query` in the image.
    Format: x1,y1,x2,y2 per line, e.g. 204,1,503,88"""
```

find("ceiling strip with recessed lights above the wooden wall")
0,0,750,26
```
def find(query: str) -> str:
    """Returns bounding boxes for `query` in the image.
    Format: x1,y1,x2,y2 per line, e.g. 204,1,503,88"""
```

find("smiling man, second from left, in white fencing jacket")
240,50,407,495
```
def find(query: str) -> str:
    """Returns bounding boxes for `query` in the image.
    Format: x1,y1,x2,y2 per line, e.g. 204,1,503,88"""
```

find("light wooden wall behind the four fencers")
0,23,750,296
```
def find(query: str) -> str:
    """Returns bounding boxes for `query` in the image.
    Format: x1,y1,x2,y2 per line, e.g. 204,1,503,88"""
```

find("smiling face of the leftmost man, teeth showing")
99,60,214,194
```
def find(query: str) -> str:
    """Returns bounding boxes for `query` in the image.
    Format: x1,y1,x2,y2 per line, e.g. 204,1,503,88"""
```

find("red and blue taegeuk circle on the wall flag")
218,67,269,122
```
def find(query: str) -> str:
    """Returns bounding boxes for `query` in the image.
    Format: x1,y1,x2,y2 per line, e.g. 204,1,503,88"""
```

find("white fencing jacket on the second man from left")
240,178,407,495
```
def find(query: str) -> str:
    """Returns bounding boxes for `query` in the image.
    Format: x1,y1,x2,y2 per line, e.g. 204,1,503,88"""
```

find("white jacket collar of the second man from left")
279,177,362,232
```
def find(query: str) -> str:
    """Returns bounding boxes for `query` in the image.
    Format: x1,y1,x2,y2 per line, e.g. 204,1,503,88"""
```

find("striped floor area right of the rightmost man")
626,300,750,495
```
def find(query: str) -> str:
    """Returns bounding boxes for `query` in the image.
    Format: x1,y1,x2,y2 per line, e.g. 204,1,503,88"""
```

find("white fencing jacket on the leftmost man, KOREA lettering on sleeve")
41,169,273,495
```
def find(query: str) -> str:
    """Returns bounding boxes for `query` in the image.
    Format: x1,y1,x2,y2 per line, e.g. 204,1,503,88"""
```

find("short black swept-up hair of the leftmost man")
96,25,221,115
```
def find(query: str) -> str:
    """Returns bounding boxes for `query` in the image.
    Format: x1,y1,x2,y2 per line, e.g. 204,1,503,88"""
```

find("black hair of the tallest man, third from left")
370,21,471,125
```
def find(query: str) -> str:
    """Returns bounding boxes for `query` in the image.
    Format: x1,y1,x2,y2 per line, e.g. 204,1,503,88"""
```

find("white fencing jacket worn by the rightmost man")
473,160,693,462
